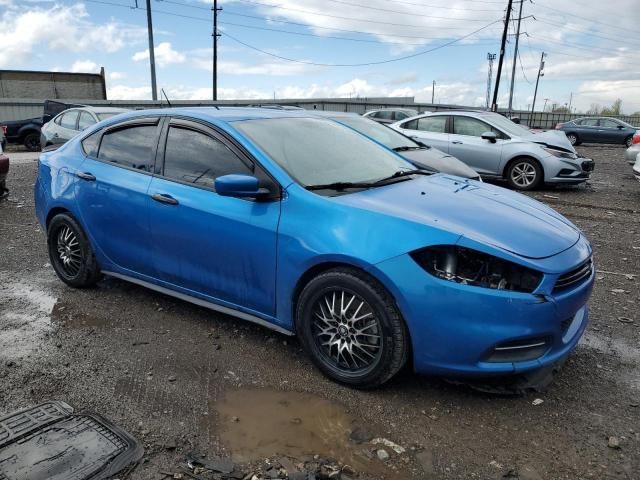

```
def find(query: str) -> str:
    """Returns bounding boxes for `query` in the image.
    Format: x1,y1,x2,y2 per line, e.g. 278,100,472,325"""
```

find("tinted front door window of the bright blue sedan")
164,127,253,188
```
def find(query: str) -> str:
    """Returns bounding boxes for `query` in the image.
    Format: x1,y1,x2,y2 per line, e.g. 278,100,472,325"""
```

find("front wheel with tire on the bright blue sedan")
296,268,410,388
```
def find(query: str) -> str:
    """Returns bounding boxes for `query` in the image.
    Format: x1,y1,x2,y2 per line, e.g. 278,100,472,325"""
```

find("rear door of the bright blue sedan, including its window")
78,117,159,276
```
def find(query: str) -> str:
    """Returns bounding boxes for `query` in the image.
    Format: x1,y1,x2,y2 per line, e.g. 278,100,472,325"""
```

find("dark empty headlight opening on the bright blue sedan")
411,245,542,293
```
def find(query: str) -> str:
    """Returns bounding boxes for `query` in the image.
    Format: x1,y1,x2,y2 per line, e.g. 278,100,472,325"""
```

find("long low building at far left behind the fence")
0,68,107,101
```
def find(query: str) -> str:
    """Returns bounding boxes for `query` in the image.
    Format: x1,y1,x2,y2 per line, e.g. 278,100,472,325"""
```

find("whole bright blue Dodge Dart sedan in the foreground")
35,108,594,388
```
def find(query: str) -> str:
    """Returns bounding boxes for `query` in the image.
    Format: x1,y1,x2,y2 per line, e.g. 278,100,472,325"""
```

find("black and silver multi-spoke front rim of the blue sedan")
312,289,382,373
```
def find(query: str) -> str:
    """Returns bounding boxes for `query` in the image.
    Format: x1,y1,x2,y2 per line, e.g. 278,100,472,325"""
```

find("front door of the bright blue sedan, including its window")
149,119,280,316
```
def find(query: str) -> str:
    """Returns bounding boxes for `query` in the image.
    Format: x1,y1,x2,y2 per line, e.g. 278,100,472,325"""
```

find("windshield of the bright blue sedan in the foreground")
233,118,415,187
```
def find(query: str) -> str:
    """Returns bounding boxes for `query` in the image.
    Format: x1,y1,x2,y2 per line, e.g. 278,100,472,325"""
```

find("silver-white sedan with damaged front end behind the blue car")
390,110,594,190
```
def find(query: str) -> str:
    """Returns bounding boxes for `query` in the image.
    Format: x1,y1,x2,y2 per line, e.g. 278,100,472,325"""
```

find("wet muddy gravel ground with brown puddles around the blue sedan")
0,146,640,480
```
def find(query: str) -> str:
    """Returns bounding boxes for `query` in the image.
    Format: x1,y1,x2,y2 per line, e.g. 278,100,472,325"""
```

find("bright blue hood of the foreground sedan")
334,174,580,259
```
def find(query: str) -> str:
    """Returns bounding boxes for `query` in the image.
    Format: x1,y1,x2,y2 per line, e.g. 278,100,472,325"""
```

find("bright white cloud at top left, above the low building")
0,4,146,66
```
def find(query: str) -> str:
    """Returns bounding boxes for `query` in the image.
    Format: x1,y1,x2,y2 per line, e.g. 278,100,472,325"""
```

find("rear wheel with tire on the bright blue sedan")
47,213,101,288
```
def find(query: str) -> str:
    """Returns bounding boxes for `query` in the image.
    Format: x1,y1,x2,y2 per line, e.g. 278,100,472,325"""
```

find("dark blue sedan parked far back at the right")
556,117,638,147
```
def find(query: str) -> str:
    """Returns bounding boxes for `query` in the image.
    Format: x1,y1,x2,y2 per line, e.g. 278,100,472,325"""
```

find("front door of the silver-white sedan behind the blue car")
449,115,504,175
